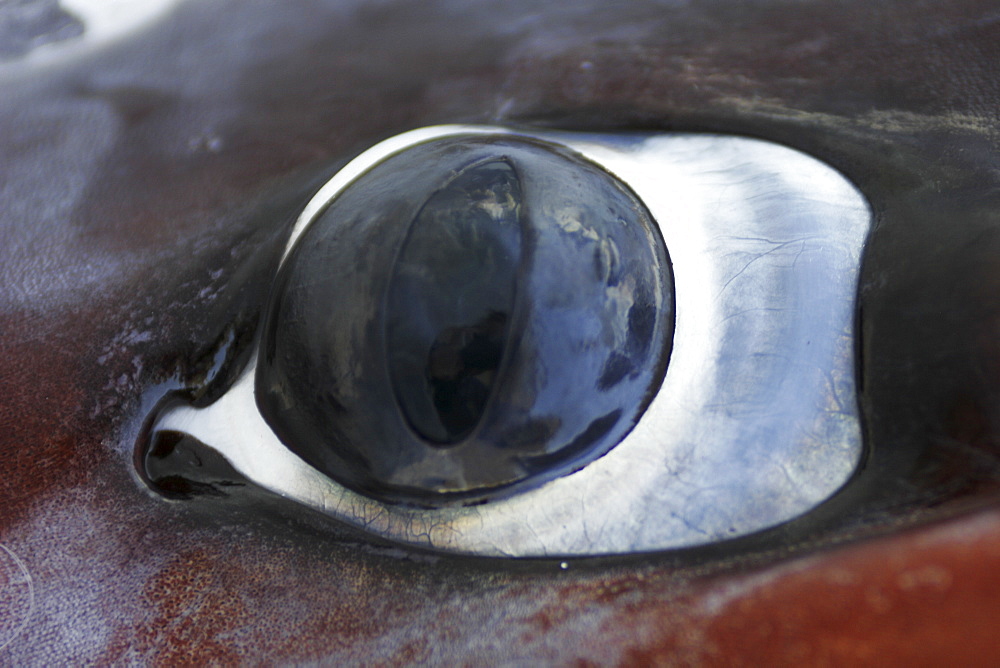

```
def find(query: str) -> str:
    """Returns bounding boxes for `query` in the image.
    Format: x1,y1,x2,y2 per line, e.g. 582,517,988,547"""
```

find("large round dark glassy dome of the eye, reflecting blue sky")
256,138,673,505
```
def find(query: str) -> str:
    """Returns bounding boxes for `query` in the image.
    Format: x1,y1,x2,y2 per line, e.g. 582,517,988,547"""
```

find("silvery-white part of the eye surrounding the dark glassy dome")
146,126,871,556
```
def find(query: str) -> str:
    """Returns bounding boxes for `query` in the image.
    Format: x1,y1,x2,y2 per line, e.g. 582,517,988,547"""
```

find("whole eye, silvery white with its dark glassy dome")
141,127,870,556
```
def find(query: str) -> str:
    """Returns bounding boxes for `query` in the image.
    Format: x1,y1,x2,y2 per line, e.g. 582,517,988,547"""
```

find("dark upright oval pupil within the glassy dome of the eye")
386,160,522,445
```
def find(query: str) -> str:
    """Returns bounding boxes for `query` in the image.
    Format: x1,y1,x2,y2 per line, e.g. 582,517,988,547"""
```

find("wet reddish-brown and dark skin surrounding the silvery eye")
0,0,1000,665
